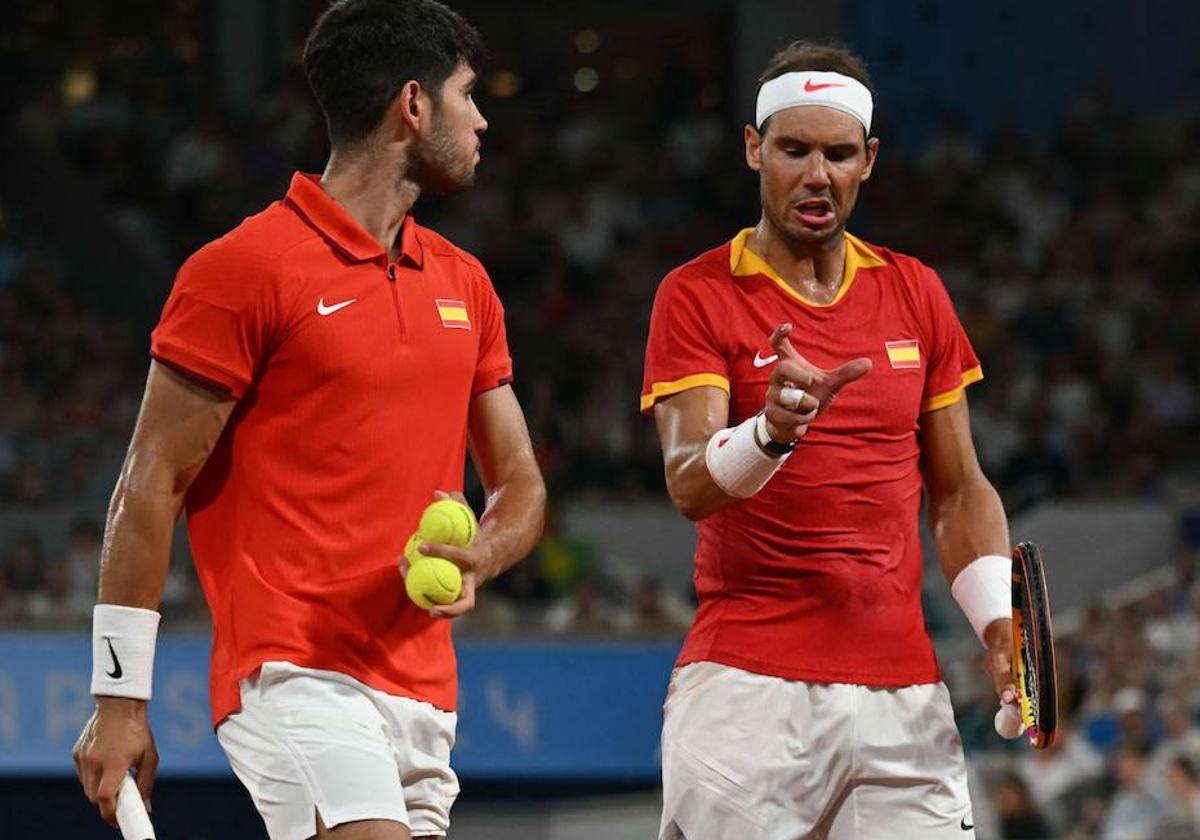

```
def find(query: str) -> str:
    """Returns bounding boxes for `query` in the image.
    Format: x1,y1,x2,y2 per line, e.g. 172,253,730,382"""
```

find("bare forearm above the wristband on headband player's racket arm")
929,474,1009,583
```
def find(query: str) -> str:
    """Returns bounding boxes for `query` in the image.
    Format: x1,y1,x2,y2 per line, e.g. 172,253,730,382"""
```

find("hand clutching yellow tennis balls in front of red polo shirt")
400,491,494,618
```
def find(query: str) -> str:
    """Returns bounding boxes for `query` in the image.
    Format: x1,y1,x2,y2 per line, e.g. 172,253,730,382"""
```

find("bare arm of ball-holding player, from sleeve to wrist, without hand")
468,385,546,582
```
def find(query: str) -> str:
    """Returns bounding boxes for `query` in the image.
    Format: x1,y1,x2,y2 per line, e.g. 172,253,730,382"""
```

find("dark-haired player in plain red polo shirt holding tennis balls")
74,0,545,840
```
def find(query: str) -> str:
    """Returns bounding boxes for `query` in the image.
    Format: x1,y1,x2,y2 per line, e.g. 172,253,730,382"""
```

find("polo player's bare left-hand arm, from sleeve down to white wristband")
98,361,235,610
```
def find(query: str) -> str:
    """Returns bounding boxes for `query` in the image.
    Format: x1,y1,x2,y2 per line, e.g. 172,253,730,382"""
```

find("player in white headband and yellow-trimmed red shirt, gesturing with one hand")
641,42,1014,840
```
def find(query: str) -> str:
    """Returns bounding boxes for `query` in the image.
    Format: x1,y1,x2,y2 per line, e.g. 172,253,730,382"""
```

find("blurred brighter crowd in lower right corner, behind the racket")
947,551,1200,840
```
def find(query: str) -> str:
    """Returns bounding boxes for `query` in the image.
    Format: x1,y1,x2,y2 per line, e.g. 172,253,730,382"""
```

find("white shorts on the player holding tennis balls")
217,662,458,840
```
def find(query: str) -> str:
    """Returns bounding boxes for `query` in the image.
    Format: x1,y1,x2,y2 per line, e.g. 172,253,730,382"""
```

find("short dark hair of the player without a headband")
304,0,484,146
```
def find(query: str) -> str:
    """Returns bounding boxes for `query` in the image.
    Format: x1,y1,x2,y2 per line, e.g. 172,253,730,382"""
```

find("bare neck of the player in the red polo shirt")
320,150,421,256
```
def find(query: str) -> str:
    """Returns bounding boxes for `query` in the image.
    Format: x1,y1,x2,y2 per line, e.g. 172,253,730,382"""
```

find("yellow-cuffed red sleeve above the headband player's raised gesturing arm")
641,268,730,413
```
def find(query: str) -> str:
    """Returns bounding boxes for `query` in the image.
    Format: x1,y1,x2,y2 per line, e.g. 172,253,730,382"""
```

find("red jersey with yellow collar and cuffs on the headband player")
642,229,983,686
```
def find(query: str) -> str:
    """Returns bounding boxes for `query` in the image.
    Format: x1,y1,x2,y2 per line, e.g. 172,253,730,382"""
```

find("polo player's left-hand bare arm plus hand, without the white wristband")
73,362,234,826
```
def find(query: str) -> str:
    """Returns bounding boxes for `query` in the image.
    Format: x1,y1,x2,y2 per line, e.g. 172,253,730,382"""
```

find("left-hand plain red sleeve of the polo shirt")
150,240,277,400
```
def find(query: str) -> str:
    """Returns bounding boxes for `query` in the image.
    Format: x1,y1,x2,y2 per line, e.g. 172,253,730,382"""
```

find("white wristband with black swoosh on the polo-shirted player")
91,604,161,700
